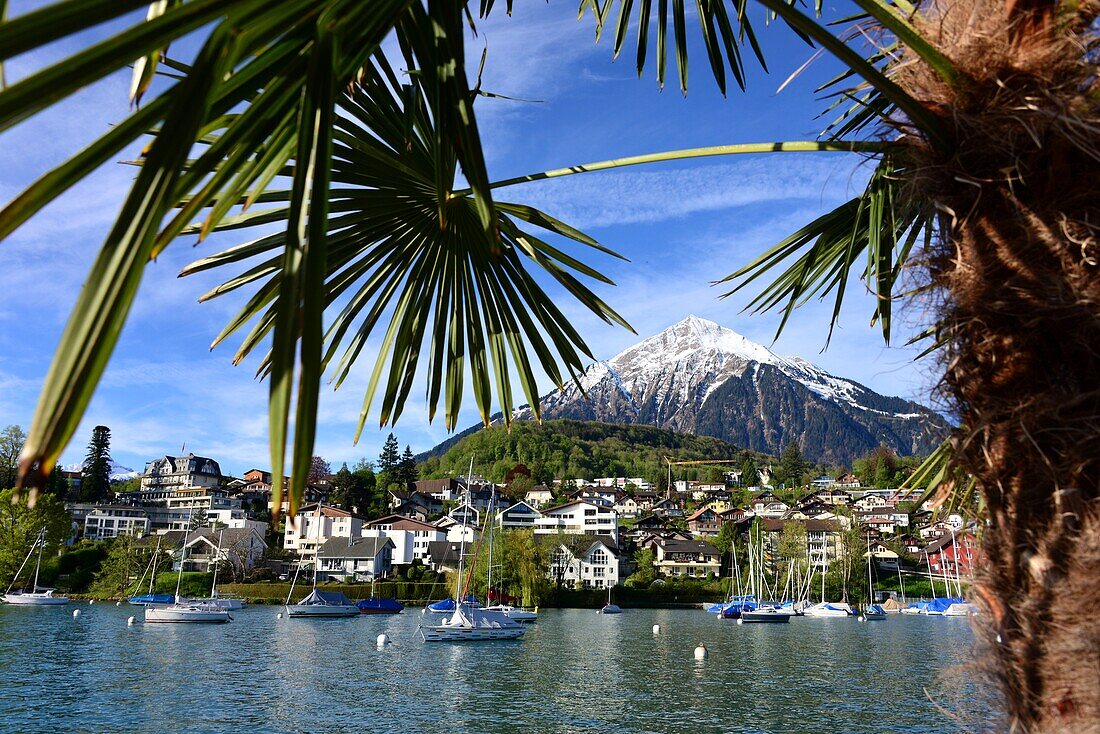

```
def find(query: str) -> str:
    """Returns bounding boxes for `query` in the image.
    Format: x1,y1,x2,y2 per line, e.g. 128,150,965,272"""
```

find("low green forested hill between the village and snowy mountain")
420,419,758,483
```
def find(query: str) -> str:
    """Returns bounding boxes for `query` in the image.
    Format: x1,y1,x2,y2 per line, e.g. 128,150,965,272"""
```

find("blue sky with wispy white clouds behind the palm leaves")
0,0,946,473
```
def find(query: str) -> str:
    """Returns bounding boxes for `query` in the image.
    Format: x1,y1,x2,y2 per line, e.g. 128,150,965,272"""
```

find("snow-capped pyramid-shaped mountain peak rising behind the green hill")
516,316,948,465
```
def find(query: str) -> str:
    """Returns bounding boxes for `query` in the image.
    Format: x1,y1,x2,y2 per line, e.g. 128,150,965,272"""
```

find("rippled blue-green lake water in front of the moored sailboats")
0,603,991,734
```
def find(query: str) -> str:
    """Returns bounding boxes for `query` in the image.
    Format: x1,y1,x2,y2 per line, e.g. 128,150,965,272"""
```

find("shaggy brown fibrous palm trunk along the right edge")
908,1,1100,732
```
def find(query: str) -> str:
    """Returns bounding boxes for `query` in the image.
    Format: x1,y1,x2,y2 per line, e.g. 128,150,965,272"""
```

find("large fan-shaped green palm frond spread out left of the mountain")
177,24,629,517
